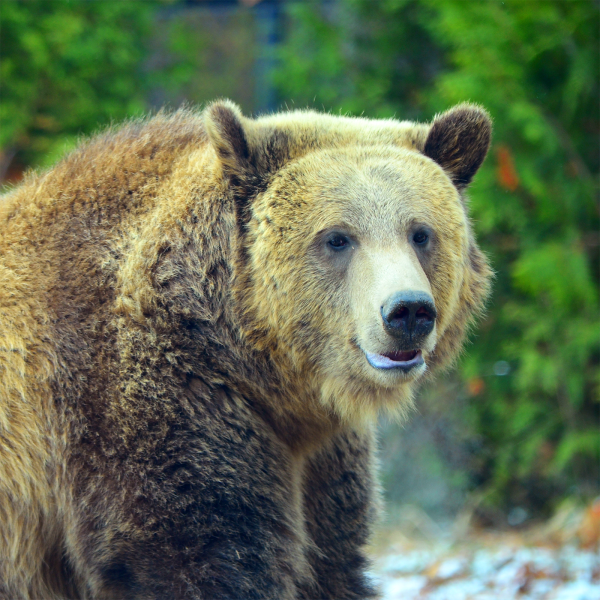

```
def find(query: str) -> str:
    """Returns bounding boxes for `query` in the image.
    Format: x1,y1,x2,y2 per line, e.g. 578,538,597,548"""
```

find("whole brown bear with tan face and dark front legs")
0,101,491,600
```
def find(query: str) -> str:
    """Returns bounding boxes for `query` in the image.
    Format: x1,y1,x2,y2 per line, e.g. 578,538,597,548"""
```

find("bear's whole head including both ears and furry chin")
204,101,491,421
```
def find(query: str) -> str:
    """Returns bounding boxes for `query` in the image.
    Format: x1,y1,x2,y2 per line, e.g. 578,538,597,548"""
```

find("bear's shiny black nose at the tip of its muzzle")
381,291,437,350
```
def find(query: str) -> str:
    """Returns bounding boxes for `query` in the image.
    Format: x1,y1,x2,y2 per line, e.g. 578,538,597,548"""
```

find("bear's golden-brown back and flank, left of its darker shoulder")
0,110,206,556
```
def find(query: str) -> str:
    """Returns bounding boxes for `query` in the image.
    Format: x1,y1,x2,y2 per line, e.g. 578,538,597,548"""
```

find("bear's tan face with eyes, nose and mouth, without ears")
204,102,489,420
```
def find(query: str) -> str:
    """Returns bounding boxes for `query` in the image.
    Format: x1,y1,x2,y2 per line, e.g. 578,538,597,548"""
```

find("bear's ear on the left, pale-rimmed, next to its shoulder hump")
204,100,251,178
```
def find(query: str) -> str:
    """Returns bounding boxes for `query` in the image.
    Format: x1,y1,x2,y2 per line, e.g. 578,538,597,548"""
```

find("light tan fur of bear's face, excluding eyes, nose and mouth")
241,145,480,422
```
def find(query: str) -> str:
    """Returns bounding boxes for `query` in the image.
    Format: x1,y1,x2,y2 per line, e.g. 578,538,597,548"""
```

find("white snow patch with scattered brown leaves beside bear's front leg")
376,544,600,600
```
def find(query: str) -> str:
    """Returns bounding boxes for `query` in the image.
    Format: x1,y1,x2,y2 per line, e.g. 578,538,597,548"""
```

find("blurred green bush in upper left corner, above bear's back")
0,0,189,173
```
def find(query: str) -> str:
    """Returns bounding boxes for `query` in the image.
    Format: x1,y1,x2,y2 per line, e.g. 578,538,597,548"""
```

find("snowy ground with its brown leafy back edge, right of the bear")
373,504,600,600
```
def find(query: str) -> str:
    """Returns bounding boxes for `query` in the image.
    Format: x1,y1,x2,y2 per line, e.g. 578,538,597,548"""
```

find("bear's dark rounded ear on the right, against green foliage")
423,103,492,190
